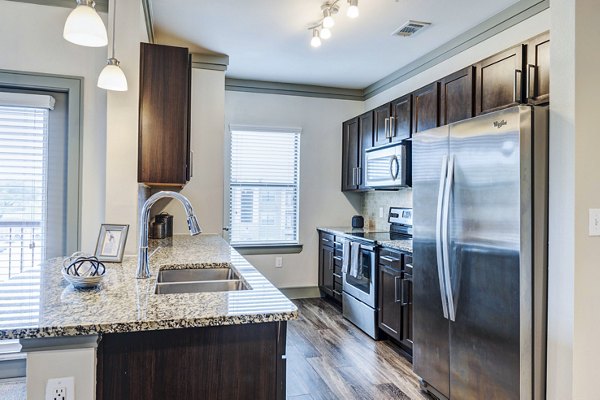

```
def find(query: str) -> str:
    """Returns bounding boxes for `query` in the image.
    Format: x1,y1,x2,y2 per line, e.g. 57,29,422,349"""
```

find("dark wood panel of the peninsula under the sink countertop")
96,322,287,400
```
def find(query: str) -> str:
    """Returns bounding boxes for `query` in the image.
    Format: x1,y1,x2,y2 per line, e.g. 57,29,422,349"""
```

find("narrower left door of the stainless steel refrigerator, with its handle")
412,126,450,397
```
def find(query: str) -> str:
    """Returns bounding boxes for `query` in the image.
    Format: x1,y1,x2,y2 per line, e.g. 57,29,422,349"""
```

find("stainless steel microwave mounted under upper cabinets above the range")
365,144,406,189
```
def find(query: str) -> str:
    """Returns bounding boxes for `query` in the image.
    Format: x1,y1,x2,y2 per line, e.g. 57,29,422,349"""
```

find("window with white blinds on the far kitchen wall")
229,126,300,245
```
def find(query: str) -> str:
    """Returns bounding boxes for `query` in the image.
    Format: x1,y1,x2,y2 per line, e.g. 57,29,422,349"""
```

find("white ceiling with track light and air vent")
152,0,518,89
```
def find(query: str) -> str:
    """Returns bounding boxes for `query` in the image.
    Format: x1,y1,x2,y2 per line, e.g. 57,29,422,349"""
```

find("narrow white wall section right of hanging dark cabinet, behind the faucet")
164,69,225,234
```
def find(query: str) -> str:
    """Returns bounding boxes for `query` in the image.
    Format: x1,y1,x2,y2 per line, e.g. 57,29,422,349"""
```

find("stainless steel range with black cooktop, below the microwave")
342,207,412,339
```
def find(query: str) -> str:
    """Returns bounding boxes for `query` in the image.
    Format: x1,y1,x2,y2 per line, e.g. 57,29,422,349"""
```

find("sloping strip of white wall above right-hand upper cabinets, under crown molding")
365,10,550,111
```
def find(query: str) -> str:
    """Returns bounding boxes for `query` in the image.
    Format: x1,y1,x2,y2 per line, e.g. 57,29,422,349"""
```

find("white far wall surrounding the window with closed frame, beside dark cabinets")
225,91,362,288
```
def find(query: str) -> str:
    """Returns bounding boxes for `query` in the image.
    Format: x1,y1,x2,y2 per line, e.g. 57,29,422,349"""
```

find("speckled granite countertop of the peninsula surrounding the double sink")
0,234,298,339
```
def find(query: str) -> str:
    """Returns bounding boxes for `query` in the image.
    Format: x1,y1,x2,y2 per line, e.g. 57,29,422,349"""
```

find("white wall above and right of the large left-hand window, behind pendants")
0,0,106,251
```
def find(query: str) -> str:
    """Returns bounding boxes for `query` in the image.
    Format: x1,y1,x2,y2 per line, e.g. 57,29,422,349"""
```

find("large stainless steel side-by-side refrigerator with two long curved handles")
412,106,548,400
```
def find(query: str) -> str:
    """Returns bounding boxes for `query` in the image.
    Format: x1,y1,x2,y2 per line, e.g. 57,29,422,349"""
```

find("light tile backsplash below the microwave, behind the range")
362,188,412,231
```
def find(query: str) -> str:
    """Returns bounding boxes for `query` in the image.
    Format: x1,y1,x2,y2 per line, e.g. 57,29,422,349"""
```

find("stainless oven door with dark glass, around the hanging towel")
343,244,377,308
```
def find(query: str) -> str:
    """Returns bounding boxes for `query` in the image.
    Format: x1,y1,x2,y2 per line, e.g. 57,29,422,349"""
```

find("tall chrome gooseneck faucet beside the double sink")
135,191,202,279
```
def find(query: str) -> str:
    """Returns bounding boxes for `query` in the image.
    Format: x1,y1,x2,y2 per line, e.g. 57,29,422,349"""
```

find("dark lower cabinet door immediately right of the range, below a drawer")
378,264,402,341
